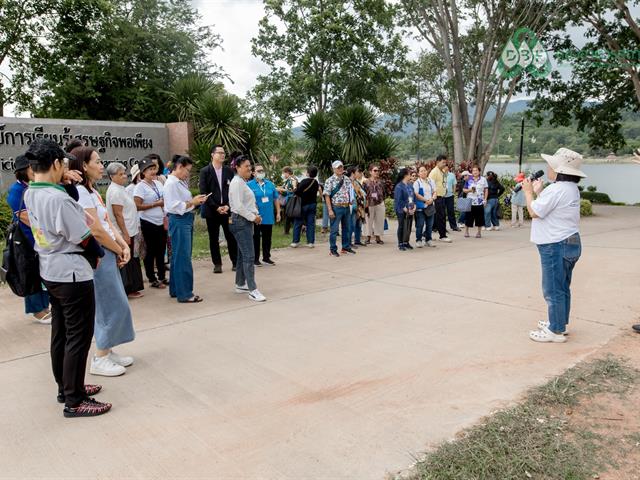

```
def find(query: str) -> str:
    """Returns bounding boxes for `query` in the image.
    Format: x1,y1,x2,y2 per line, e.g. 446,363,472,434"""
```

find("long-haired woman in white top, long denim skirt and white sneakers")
69,147,135,377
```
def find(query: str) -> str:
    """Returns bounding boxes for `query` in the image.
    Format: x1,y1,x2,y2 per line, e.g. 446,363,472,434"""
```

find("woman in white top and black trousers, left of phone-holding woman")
133,158,169,288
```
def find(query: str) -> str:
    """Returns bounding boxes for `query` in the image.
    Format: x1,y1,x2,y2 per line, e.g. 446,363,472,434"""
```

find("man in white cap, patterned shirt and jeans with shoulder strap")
323,160,356,257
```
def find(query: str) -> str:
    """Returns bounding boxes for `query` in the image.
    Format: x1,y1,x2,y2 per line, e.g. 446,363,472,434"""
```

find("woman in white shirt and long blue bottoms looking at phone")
164,155,207,303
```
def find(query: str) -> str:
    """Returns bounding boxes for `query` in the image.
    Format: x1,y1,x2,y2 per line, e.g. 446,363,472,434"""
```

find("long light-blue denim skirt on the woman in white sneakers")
94,249,136,350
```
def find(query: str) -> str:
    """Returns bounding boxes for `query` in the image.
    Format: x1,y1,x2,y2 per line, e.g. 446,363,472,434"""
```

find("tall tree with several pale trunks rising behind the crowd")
401,0,557,168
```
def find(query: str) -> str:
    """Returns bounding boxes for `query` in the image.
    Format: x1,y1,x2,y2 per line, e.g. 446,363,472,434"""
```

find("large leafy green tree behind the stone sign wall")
13,0,220,121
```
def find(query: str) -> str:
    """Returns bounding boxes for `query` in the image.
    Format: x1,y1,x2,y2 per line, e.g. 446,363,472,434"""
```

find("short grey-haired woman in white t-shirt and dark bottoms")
107,162,144,298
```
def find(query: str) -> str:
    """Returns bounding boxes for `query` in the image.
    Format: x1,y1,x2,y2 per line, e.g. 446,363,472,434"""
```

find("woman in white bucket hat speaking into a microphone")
522,148,586,343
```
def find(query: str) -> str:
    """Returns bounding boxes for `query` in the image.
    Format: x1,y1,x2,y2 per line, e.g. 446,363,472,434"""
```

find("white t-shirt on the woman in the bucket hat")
531,182,580,245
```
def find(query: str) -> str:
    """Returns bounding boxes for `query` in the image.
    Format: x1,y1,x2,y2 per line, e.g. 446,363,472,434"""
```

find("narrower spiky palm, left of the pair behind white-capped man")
302,111,340,178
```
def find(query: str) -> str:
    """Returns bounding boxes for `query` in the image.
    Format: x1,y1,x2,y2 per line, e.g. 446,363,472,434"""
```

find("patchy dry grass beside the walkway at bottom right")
405,356,640,480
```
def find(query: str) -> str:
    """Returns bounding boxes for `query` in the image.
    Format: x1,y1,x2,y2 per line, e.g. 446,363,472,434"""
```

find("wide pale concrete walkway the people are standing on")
0,207,640,479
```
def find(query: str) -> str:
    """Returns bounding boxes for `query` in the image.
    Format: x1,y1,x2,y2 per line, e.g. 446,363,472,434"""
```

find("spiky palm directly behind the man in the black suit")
196,91,243,151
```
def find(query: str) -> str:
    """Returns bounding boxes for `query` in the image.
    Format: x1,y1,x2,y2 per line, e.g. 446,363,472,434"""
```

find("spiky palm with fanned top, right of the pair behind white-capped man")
335,104,376,166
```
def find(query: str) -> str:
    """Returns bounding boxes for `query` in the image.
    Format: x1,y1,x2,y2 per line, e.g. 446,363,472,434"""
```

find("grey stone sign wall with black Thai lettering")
0,117,178,192
